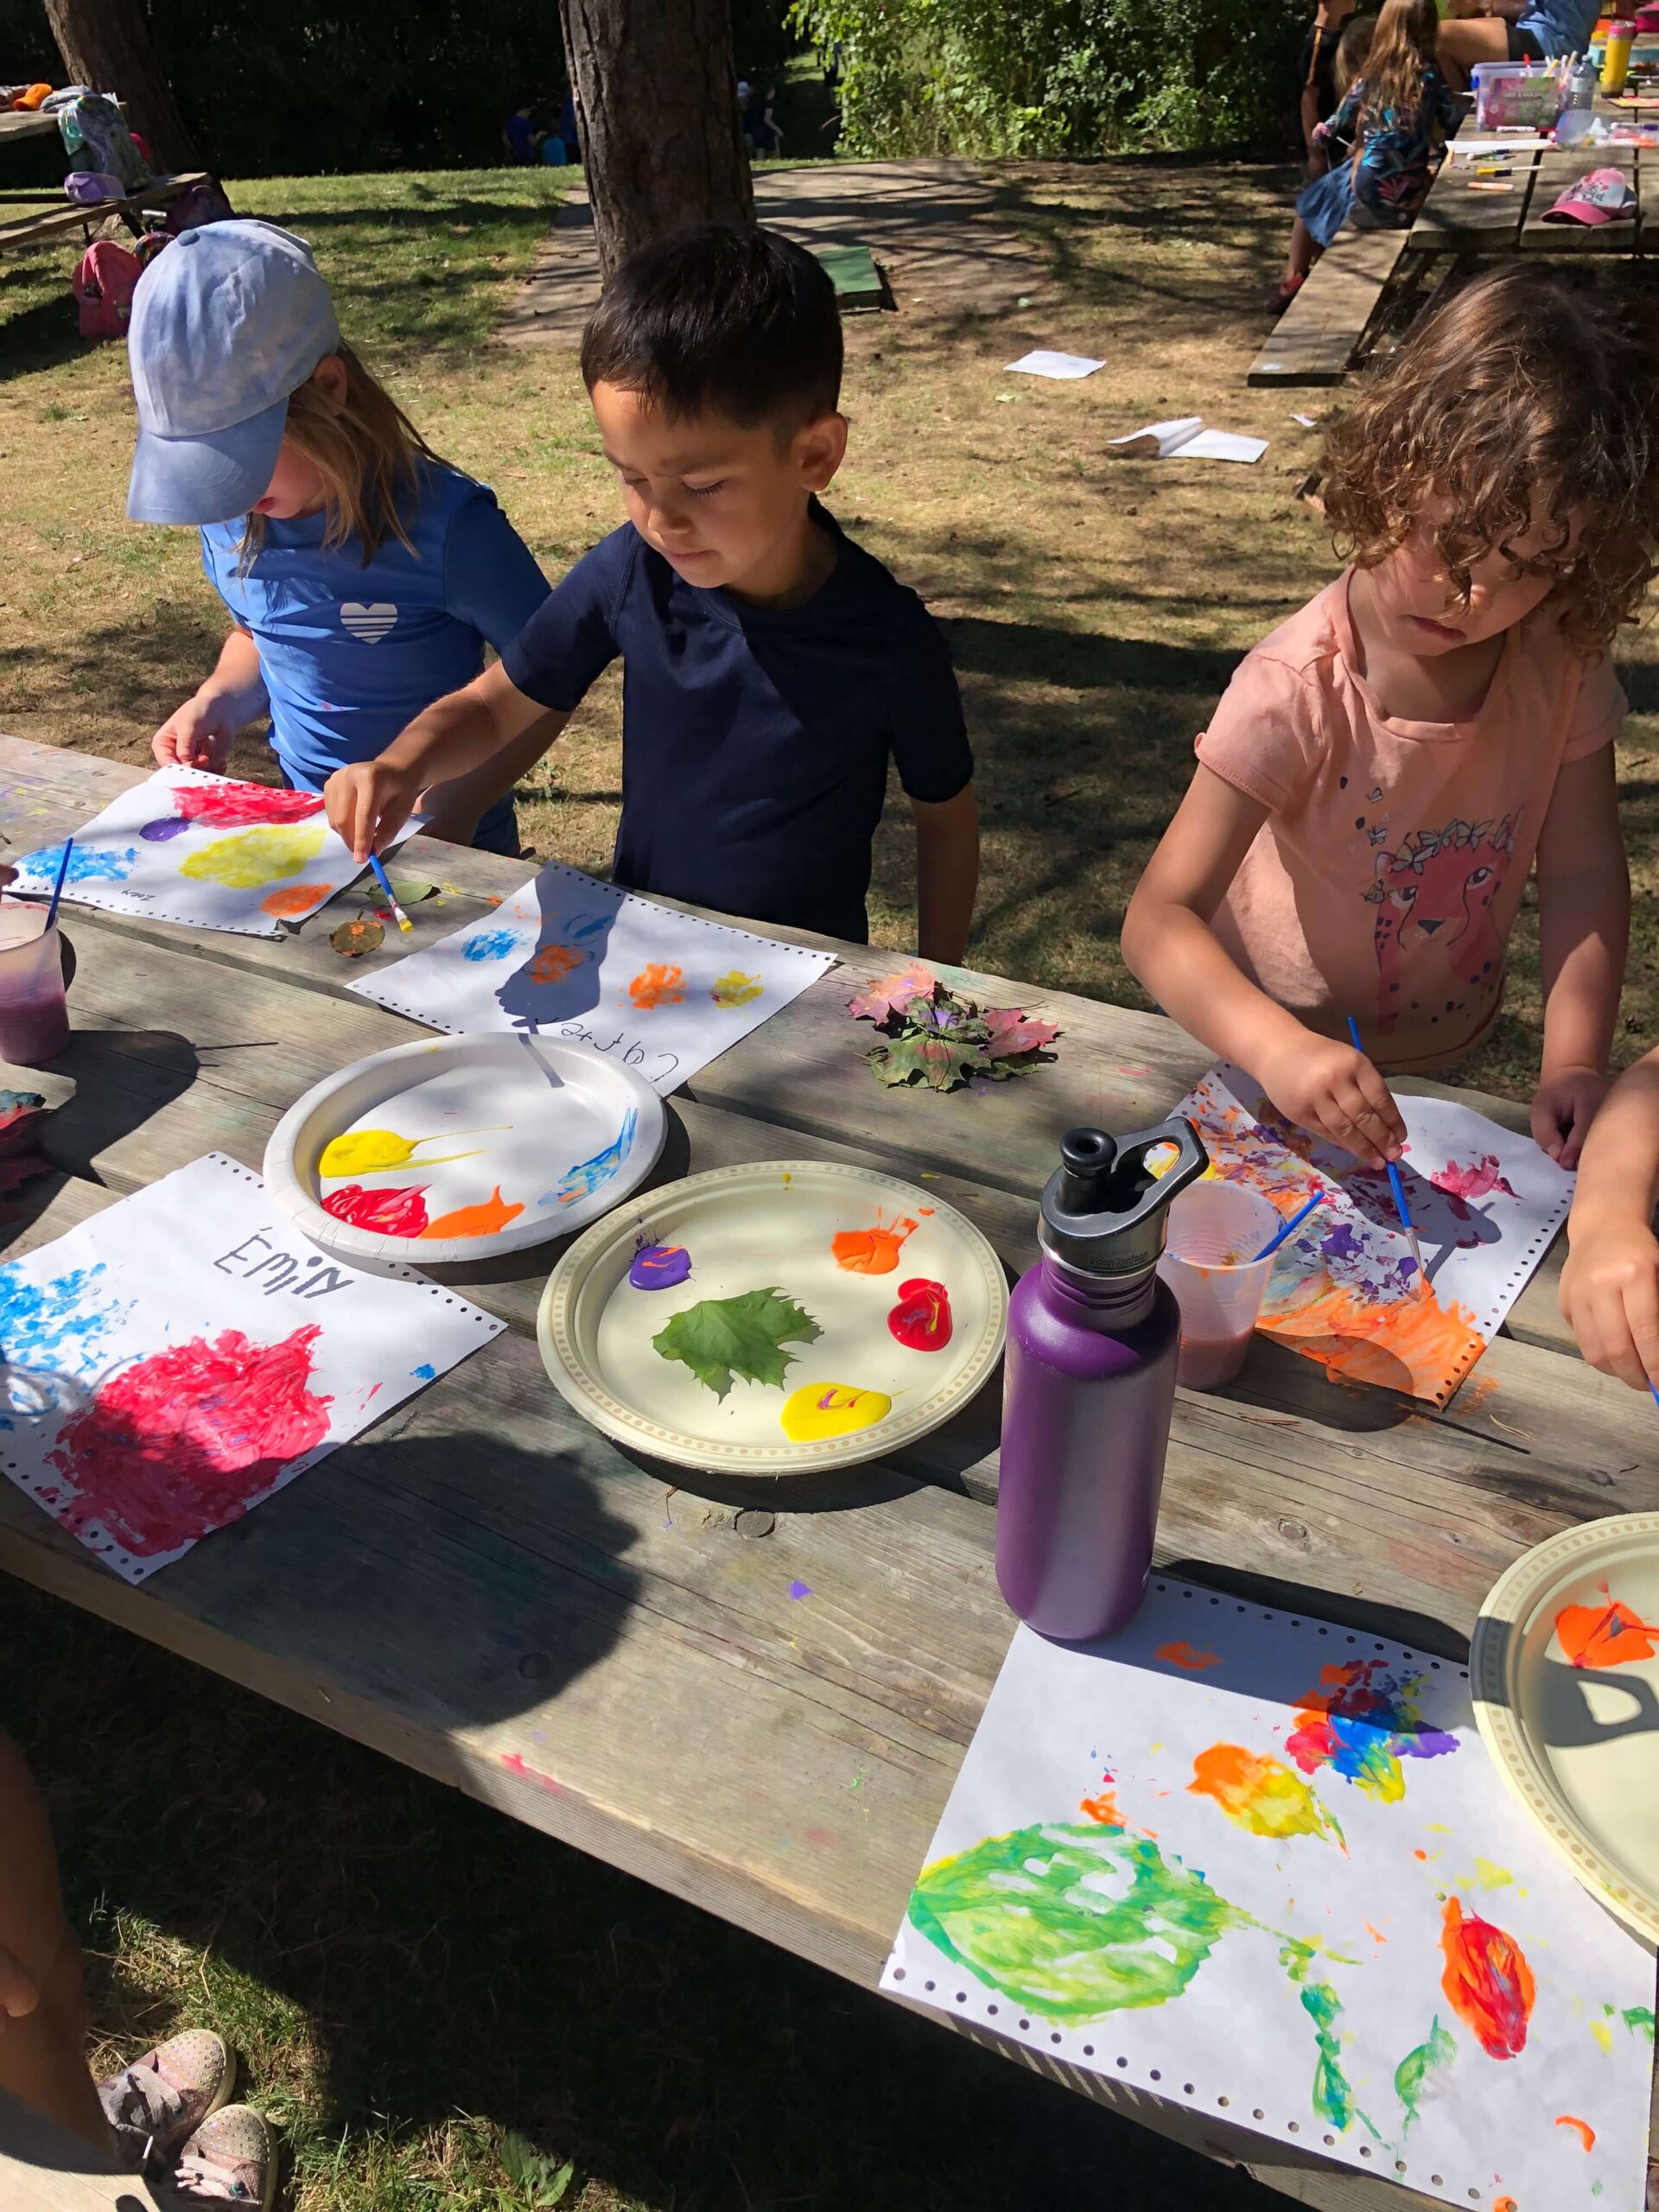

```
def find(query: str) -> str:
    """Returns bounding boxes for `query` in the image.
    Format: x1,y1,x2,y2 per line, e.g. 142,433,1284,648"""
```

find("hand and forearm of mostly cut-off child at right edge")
1561,1053,1659,1389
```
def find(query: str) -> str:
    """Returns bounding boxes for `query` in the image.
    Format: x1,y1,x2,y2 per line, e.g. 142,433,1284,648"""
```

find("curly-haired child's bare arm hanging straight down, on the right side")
1533,746,1630,1168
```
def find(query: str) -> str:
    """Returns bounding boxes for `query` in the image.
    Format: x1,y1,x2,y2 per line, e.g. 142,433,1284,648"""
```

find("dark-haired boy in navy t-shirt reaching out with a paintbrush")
327,226,980,963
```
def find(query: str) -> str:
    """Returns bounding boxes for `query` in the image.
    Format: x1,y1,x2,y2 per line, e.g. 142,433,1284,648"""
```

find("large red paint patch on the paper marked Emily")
51,1323,332,1560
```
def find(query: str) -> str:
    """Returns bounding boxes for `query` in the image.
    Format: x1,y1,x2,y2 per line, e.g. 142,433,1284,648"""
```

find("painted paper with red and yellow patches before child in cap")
13,767,389,938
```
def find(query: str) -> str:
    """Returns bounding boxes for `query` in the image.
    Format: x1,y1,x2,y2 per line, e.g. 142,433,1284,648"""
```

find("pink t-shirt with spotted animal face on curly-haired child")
1197,570,1626,1071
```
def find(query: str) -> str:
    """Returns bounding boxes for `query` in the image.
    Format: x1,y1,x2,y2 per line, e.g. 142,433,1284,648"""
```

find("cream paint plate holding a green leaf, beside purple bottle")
537,1161,1008,1476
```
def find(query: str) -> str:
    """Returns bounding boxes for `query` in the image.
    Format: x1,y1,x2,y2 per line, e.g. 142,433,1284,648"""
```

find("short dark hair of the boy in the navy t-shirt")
582,224,841,434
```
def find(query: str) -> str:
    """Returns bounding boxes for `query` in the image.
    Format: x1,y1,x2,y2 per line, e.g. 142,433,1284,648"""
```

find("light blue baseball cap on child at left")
126,221,340,522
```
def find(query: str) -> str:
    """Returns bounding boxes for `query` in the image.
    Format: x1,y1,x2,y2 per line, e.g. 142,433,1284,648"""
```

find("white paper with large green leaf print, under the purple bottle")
882,1580,1655,2212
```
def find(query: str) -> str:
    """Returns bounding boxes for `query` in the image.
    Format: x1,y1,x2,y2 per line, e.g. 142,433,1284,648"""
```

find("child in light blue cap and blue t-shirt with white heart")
126,221,546,856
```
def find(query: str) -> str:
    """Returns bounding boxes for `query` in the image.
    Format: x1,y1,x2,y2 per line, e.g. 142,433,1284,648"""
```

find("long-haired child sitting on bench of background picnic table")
1281,0,1462,311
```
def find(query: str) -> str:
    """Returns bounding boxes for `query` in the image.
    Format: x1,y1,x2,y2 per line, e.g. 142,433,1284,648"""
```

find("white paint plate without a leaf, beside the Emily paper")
265,1035,668,1265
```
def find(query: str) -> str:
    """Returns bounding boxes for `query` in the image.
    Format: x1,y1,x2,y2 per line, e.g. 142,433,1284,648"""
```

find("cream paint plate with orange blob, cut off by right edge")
1469,1513,1659,1944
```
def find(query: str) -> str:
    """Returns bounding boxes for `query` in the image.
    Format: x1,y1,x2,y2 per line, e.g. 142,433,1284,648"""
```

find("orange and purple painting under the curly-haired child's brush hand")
1177,1062,1575,1405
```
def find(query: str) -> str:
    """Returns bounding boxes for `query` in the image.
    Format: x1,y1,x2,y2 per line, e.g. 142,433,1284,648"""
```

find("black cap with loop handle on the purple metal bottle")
1042,1119,1210,1279
